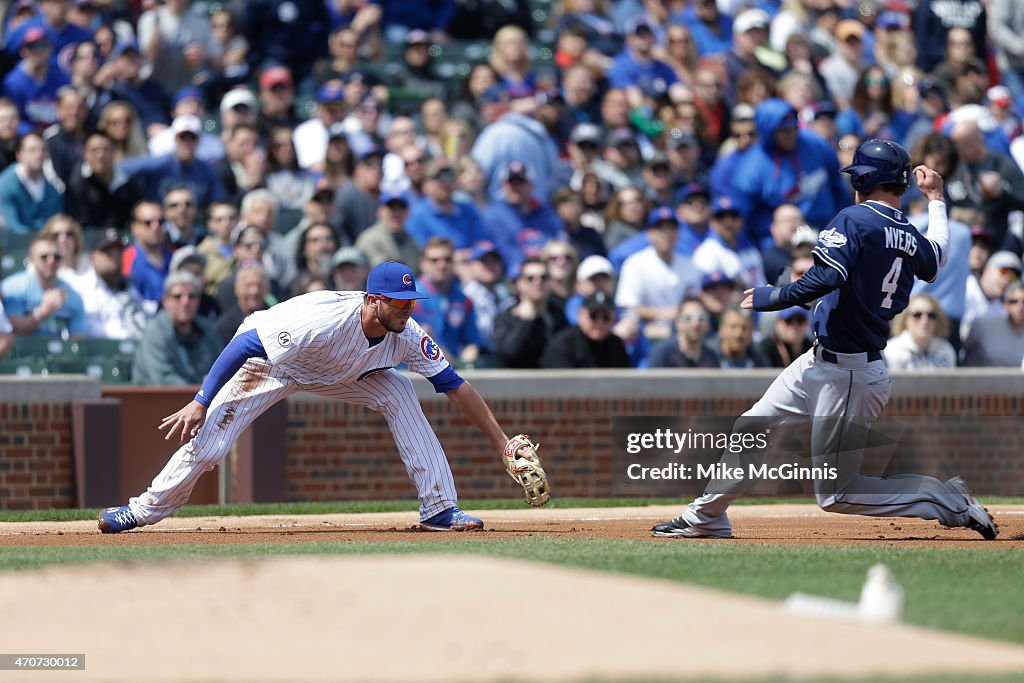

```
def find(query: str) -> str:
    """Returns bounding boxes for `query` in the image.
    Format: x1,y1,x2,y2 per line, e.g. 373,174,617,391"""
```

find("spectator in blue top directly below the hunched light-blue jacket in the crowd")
483,161,564,272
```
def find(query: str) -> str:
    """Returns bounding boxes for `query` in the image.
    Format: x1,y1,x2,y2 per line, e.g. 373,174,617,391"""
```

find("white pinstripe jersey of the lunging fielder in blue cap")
239,291,449,384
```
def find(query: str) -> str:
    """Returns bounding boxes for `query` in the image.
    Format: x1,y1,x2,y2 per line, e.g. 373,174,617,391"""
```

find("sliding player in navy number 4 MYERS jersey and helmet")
651,140,998,540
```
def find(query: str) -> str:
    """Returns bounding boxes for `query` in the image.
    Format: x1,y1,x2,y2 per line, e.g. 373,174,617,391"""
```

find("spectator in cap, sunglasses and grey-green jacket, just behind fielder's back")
132,270,221,386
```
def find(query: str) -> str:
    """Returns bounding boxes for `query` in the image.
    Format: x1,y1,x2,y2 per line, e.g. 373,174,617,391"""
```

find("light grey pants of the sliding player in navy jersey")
683,348,969,532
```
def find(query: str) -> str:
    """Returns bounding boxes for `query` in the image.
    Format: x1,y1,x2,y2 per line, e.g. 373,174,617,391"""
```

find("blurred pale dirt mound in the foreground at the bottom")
0,555,1024,683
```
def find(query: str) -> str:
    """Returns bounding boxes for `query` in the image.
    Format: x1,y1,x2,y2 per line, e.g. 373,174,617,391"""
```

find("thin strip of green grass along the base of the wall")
0,496,1024,522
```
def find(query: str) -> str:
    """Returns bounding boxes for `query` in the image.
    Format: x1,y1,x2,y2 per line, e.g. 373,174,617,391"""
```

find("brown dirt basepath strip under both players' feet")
0,505,1024,549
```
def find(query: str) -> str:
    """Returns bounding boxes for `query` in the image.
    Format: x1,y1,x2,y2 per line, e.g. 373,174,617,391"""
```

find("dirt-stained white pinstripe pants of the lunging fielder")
128,358,458,525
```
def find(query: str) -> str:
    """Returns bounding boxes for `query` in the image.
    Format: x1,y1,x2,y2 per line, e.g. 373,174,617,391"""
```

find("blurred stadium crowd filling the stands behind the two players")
0,0,1024,384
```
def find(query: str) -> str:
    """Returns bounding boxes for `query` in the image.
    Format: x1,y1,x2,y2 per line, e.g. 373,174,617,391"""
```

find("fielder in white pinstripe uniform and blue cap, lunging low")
99,261,509,533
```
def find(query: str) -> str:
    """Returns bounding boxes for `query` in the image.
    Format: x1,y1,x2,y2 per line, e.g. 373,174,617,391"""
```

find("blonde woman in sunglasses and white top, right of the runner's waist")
883,294,956,370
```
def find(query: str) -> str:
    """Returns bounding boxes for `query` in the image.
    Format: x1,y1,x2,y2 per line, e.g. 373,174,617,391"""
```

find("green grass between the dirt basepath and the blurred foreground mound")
0,536,1024,644
